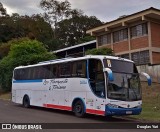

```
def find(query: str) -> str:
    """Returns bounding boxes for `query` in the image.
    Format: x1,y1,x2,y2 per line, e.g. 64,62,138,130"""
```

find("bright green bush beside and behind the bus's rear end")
0,38,56,91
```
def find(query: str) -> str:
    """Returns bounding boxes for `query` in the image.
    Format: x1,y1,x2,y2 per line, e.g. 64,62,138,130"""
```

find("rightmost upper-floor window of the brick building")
131,23,148,38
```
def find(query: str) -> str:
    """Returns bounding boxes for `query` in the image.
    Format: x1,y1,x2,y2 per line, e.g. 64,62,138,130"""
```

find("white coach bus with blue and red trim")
12,55,151,117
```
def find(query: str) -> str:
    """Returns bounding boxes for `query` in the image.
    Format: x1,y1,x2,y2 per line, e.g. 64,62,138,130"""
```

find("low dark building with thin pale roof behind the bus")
53,40,96,58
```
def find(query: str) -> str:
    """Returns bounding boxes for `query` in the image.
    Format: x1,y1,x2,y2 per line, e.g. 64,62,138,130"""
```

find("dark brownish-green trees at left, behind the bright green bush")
0,13,54,50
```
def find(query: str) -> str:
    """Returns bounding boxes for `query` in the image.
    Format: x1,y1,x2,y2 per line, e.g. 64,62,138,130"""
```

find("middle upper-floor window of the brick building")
113,28,128,42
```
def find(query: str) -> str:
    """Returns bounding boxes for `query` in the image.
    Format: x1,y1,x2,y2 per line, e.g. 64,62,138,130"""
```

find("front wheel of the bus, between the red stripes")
73,100,85,117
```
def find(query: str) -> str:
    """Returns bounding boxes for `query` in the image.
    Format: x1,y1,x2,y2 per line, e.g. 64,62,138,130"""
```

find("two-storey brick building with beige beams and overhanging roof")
87,7,160,82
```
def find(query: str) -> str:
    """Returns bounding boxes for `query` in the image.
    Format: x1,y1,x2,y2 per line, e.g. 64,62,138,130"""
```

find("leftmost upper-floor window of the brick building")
98,34,111,46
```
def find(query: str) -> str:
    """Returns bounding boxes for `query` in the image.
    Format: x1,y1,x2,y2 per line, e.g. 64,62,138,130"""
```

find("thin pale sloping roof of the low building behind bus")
53,40,96,53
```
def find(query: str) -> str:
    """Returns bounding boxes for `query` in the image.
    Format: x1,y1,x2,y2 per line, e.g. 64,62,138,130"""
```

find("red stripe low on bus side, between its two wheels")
43,104,72,111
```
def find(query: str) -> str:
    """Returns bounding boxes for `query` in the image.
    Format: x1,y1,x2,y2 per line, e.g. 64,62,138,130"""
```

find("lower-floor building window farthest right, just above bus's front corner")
131,50,150,65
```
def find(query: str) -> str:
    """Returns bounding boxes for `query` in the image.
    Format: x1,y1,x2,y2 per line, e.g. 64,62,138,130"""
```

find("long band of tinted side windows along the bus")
14,61,86,80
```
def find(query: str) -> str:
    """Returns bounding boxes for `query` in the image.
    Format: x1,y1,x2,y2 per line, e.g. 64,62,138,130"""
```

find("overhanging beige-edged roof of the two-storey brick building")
87,7,160,35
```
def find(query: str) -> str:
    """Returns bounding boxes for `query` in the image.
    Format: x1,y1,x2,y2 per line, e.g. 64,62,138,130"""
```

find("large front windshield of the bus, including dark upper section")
104,59,141,101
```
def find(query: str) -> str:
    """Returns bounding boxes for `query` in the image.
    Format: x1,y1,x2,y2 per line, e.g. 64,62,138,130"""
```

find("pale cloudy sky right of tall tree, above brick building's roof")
69,0,160,22
